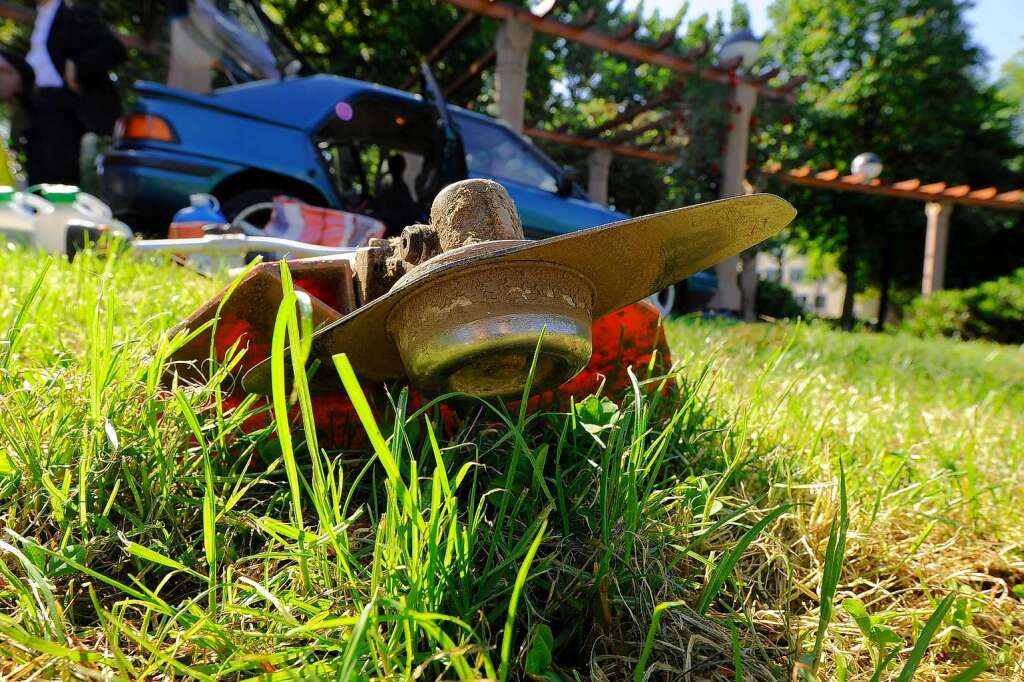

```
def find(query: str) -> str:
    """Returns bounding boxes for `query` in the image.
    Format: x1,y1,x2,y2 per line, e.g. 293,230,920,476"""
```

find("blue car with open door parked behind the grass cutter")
99,75,626,238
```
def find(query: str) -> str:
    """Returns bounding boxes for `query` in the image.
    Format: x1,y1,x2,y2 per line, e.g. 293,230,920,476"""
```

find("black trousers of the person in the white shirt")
26,88,86,184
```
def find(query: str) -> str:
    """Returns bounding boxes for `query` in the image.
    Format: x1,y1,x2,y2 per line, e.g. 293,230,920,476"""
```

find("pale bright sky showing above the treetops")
627,0,1024,79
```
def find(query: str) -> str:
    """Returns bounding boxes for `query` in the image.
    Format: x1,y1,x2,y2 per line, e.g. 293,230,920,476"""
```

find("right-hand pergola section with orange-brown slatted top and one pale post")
765,164,1024,296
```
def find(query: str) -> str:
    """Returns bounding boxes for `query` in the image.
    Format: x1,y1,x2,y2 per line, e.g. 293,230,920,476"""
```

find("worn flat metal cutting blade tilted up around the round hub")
243,195,796,394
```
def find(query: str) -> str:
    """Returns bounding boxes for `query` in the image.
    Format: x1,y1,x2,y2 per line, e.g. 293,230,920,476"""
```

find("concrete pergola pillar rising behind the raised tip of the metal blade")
708,82,758,311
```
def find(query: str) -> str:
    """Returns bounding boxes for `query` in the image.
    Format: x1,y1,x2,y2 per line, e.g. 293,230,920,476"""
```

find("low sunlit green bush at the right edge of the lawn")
906,267,1024,343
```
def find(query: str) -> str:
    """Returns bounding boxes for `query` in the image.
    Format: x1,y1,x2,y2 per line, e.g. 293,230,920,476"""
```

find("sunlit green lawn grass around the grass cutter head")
0,246,1024,680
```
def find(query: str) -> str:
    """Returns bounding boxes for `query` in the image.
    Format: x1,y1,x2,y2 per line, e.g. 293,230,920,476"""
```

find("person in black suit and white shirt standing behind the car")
26,0,127,184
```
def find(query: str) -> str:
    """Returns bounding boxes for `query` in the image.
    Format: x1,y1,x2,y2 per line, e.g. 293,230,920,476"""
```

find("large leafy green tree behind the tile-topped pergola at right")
762,0,1021,328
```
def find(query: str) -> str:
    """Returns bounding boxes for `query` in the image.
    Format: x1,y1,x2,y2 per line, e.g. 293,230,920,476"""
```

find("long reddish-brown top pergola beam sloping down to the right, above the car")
444,0,793,99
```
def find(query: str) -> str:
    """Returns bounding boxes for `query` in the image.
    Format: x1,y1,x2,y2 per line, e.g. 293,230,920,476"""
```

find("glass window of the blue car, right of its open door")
458,116,558,193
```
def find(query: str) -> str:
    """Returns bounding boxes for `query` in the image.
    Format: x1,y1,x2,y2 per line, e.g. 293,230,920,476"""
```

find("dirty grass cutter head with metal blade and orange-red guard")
166,179,796,446
